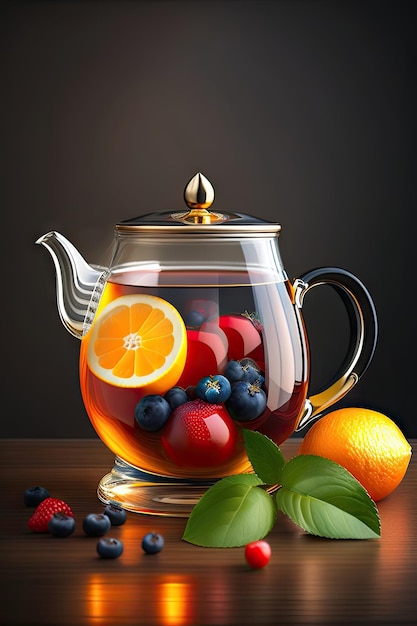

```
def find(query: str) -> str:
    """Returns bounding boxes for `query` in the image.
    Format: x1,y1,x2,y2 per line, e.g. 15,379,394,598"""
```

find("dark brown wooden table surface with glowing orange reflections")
0,439,417,626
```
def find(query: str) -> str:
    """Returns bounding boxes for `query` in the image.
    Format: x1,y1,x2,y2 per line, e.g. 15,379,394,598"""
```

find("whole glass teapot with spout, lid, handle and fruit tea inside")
36,173,377,517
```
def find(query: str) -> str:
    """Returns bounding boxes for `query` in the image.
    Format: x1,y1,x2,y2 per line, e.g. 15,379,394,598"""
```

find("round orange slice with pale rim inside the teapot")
87,294,187,393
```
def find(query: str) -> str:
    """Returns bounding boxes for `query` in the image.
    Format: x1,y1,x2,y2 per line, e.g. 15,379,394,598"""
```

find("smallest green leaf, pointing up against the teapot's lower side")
243,428,285,485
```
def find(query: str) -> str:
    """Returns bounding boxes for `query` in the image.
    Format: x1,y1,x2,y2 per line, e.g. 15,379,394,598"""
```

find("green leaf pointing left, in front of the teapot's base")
182,474,277,548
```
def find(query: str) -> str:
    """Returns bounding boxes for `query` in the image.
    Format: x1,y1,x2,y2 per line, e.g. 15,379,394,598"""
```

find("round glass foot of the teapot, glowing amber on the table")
97,457,216,517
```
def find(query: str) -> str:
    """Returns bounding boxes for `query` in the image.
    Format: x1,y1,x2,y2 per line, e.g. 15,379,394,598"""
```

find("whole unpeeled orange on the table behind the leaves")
298,407,411,501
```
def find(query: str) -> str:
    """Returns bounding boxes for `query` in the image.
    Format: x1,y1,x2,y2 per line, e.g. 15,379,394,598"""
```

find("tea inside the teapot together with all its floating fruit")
80,268,308,479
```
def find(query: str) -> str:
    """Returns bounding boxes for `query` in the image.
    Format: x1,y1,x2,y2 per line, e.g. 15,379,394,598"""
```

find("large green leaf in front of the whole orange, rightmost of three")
275,455,381,539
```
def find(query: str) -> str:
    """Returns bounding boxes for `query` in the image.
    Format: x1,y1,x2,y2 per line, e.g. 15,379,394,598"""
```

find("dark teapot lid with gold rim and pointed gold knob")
116,172,281,234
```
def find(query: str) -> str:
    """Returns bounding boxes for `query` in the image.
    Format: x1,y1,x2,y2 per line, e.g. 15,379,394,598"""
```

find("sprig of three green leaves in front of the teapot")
182,429,381,548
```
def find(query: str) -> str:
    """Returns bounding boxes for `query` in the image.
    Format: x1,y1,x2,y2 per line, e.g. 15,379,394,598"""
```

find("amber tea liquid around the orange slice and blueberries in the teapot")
80,271,308,479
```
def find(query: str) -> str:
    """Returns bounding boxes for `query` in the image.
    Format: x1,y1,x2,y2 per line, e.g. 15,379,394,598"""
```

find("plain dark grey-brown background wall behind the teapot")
0,0,417,437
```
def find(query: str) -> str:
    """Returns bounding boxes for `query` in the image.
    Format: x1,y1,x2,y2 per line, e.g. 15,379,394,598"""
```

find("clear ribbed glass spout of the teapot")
35,231,108,339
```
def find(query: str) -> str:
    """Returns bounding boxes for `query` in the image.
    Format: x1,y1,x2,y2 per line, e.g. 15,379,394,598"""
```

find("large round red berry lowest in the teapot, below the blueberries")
161,399,237,467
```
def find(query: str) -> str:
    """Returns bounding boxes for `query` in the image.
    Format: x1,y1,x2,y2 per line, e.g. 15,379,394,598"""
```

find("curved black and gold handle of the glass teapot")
294,267,378,430
